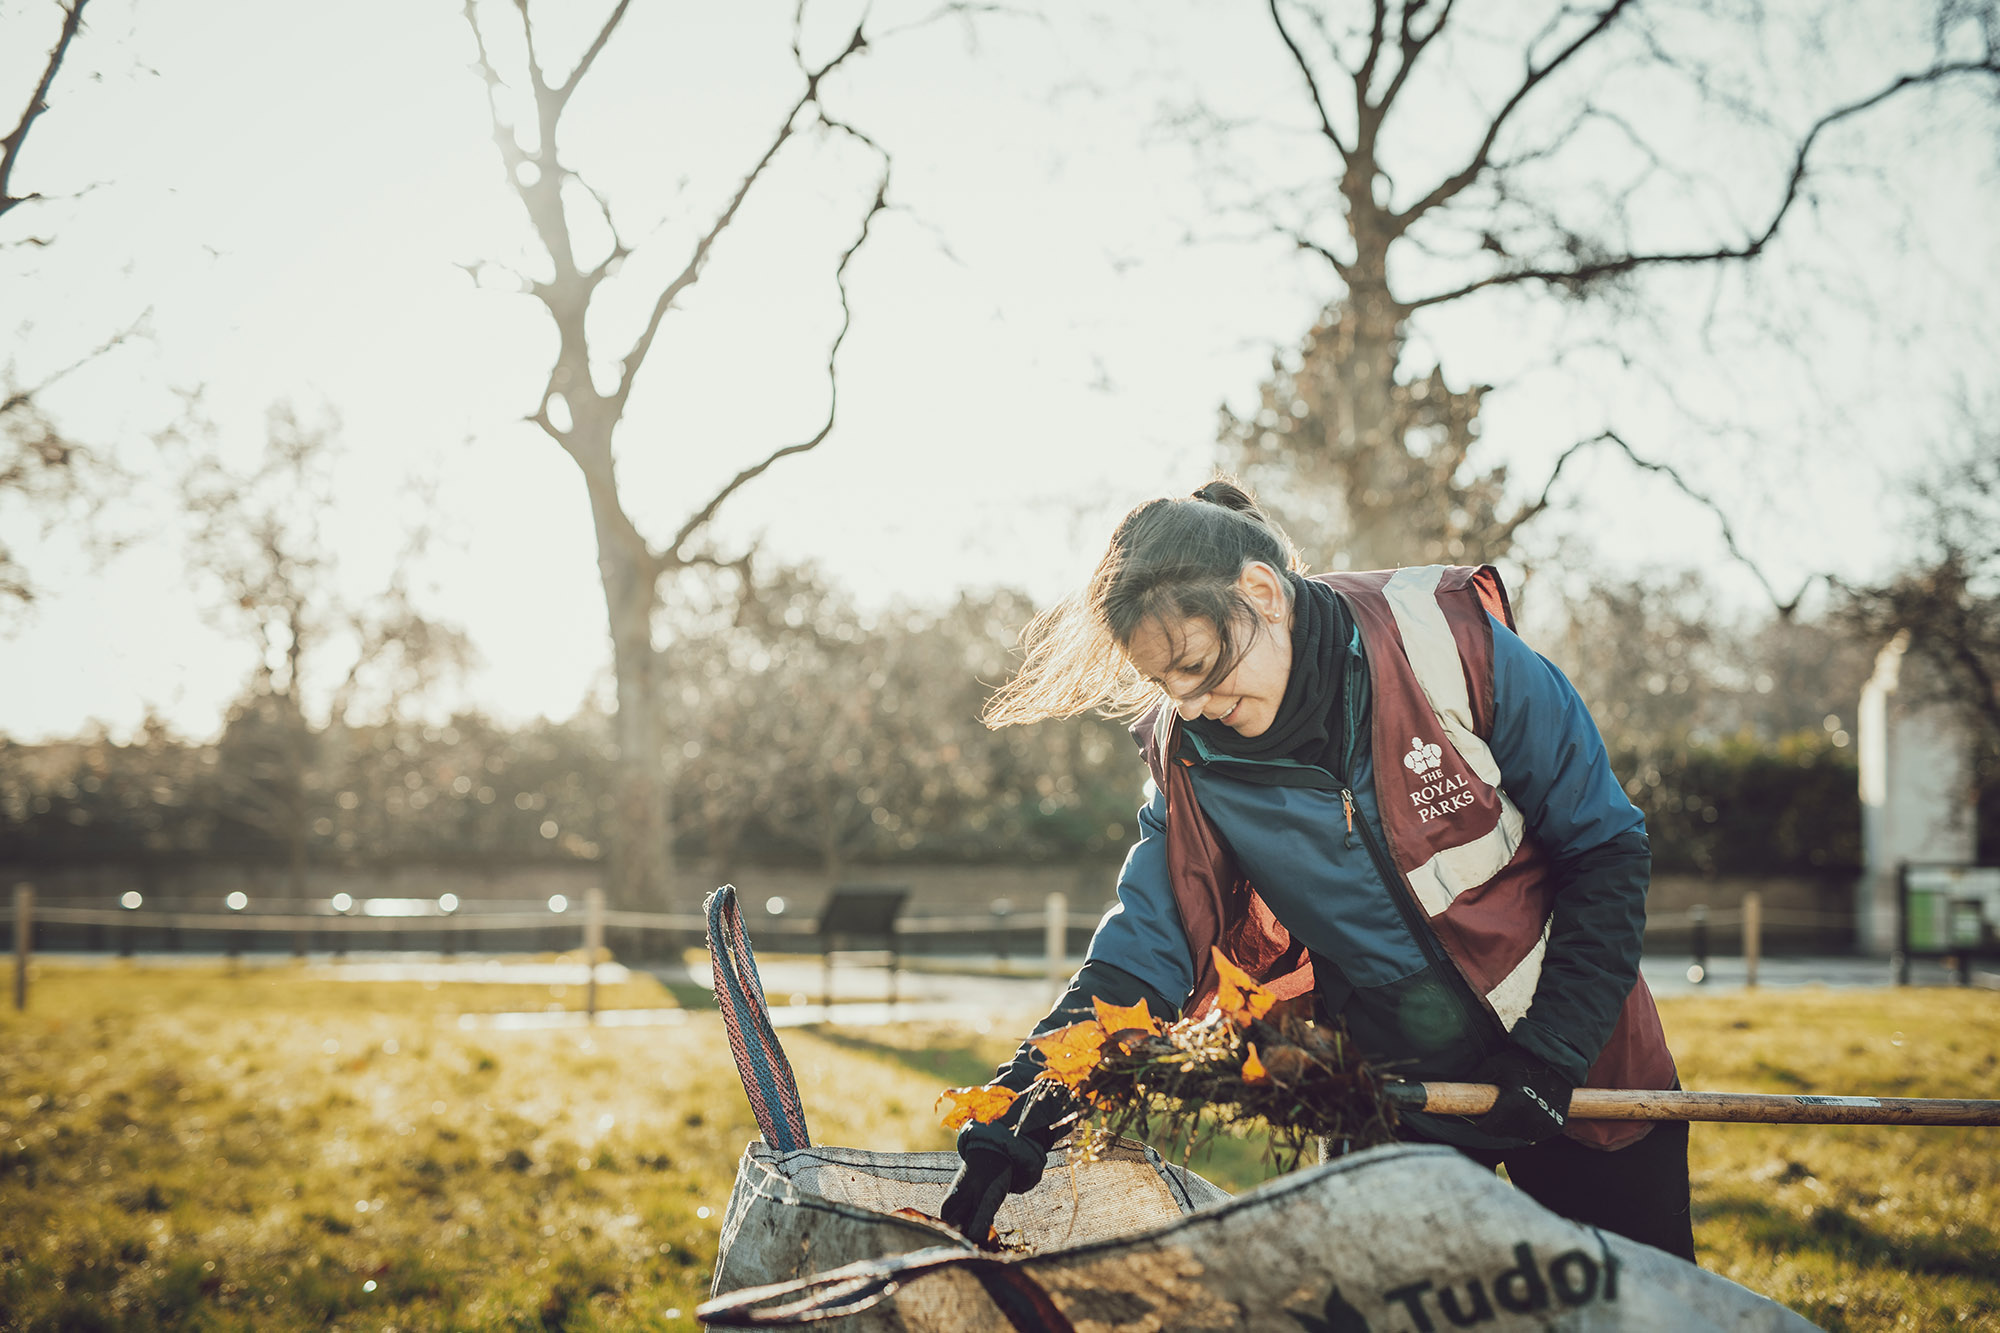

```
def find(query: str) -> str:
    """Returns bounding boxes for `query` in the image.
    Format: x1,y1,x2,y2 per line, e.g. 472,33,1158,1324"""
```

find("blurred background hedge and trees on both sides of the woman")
0,528,1904,889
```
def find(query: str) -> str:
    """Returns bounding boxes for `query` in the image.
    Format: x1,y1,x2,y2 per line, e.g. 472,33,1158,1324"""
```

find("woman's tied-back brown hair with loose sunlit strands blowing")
984,476,1304,729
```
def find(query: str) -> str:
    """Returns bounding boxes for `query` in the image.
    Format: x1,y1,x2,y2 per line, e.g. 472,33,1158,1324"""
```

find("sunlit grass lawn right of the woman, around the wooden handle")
1660,989,2000,1331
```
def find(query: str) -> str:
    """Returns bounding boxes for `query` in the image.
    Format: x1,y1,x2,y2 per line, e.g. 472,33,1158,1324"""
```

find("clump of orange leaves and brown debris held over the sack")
940,951,1396,1169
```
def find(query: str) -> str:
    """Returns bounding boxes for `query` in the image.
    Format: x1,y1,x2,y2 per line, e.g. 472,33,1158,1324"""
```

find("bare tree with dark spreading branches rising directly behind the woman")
1222,0,2000,564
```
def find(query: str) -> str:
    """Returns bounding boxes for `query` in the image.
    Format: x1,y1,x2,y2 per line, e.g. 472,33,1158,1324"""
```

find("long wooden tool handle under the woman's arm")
1388,1083,2000,1125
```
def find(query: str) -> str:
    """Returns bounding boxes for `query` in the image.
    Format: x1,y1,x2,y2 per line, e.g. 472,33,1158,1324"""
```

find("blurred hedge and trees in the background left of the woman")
0,568,1144,883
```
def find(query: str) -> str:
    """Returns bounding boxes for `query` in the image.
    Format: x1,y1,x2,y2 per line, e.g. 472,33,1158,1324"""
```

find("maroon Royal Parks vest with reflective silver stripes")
1144,564,1674,1149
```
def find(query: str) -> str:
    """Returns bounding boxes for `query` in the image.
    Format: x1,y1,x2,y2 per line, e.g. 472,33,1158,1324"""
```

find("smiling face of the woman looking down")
1126,564,1292,737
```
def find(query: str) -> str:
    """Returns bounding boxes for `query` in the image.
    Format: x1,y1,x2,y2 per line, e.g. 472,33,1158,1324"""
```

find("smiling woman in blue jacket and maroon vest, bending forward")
942,480,1694,1261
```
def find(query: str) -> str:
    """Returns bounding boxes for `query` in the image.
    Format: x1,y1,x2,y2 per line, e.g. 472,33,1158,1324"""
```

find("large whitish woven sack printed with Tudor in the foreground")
696,1145,1814,1333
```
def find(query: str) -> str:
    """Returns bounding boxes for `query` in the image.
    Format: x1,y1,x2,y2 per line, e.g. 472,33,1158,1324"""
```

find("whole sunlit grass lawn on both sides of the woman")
0,961,2000,1333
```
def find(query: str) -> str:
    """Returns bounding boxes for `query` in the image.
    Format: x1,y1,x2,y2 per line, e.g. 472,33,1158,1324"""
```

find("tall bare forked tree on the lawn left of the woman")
466,0,890,905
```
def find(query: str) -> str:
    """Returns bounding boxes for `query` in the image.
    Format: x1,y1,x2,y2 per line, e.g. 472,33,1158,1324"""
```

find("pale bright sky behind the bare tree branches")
0,0,2000,741
